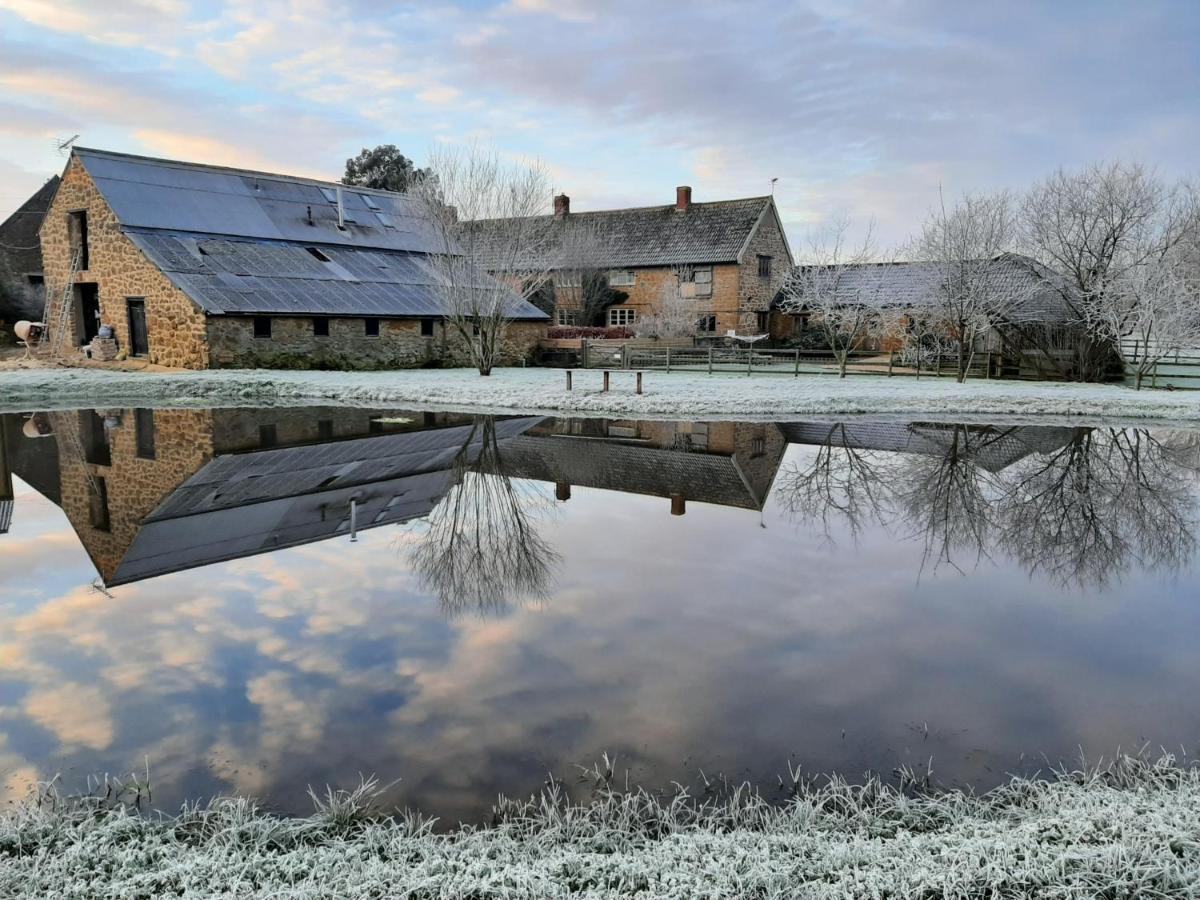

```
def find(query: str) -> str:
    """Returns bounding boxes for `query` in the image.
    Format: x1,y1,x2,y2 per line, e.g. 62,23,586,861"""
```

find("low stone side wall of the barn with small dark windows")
208,316,546,370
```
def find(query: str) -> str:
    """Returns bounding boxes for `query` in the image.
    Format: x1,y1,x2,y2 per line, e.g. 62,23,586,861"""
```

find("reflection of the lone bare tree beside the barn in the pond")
412,416,559,616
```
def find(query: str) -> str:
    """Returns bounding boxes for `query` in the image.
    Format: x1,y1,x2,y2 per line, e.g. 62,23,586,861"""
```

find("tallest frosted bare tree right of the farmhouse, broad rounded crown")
1020,162,1200,380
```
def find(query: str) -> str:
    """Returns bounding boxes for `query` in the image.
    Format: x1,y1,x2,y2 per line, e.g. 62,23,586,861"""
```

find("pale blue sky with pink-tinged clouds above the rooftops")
0,0,1200,250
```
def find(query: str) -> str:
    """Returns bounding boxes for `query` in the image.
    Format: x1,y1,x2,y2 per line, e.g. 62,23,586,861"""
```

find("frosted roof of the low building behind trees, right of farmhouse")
772,253,1078,323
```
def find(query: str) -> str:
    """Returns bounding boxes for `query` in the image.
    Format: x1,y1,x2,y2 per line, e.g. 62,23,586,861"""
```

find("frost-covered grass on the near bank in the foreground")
0,757,1200,898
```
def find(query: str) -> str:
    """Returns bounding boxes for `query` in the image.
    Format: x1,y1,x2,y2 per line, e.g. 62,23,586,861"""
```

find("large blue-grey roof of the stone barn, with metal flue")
73,148,546,319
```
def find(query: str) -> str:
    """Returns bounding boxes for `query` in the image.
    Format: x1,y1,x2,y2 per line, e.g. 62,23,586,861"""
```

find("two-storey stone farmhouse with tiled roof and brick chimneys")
466,186,793,335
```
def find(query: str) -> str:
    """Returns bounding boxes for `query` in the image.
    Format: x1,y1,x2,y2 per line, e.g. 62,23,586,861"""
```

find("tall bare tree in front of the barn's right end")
413,144,557,376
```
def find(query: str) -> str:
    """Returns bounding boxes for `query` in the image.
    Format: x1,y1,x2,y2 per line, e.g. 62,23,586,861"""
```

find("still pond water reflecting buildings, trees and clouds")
0,408,1200,821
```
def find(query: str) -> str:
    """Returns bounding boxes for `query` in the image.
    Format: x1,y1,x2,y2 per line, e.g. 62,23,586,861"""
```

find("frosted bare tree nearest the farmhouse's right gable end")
780,220,896,378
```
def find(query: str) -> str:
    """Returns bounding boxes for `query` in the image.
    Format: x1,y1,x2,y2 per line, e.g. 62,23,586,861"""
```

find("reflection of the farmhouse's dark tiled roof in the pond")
502,434,766,509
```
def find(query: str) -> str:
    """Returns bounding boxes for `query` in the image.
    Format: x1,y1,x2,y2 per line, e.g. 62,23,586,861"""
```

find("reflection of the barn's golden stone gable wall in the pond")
49,409,214,582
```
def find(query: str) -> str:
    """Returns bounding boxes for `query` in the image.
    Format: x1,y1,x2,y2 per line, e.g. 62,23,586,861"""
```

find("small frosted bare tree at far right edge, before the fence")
1084,252,1200,390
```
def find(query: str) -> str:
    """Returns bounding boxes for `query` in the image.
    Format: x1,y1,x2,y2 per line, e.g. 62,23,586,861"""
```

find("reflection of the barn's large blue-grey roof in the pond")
106,418,541,586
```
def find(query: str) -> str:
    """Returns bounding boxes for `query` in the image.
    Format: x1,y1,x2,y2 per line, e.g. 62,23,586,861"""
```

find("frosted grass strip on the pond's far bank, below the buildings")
0,368,1200,421
